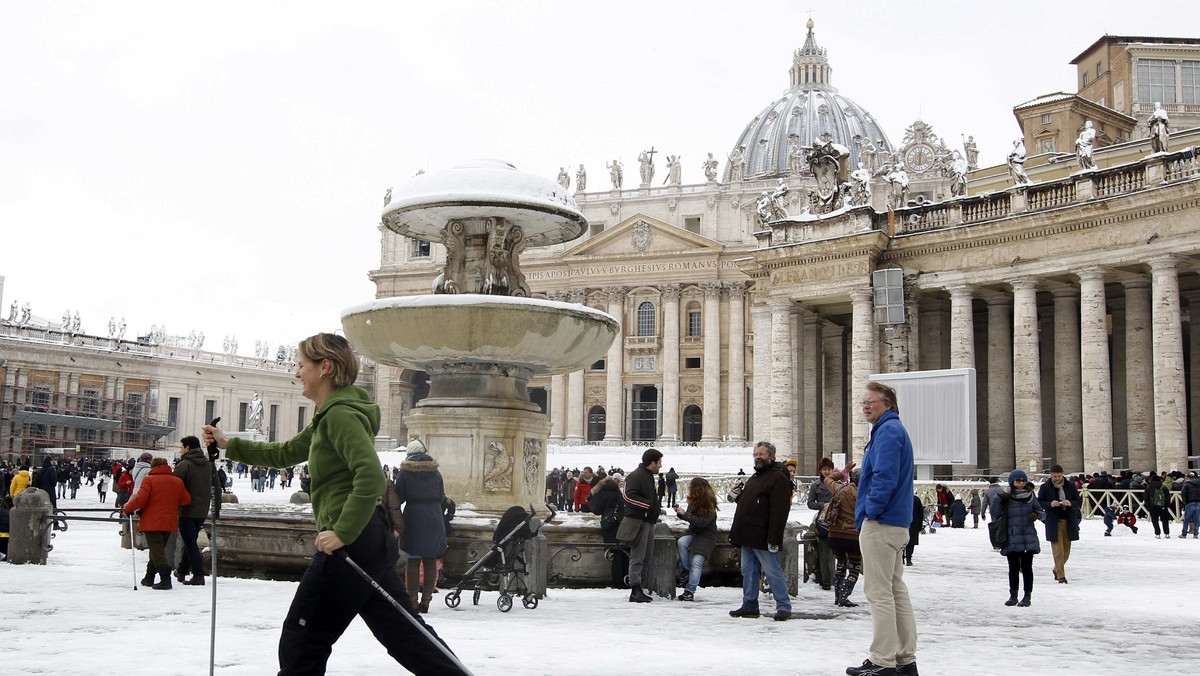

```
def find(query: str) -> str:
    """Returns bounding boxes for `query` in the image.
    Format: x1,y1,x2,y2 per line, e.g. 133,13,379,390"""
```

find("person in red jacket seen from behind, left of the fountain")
125,457,192,590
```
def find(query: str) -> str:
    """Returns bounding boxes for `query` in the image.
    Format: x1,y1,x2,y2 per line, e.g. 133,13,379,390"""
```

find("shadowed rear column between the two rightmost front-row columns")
1124,277,1156,472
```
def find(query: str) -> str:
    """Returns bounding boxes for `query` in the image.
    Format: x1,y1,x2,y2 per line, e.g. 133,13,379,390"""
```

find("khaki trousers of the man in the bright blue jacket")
858,521,917,666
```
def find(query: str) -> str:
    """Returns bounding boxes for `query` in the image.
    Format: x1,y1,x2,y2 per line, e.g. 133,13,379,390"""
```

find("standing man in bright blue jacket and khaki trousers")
846,382,917,676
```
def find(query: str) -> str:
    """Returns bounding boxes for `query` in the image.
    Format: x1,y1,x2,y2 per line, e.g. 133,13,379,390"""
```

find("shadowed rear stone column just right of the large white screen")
988,294,1016,474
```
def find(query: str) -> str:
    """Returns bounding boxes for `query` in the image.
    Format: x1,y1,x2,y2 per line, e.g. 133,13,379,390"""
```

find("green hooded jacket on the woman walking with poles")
226,385,386,544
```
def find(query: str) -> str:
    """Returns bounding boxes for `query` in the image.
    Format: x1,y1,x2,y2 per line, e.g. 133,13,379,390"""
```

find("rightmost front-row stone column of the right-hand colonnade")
1134,256,1188,472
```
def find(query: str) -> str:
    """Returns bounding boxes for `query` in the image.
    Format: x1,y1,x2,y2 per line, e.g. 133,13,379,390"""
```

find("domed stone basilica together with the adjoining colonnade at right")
371,23,1200,474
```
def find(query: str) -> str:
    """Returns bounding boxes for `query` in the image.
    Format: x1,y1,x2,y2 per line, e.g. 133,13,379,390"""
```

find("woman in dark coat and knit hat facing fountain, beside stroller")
396,439,446,612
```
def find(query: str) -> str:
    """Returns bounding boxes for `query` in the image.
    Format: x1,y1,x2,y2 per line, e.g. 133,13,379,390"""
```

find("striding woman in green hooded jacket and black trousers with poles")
204,334,462,676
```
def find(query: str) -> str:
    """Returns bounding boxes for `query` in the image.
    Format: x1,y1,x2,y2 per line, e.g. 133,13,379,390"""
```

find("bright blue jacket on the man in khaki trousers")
854,411,913,531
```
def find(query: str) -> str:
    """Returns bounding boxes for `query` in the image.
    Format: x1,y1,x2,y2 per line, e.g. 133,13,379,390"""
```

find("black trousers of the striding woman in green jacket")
280,508,462,676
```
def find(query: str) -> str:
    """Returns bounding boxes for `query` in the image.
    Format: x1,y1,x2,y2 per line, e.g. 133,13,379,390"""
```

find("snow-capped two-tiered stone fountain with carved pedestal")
342,160,618,512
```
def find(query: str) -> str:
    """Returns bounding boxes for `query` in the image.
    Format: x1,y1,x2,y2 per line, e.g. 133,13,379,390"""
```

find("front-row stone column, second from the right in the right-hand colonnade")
1080,268,1112,473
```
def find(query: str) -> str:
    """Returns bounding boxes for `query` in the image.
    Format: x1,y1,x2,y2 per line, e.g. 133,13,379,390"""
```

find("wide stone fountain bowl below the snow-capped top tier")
342,294,619,375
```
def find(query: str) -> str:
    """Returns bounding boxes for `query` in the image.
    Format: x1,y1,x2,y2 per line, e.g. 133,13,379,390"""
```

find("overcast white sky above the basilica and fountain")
0,0,1200,354
